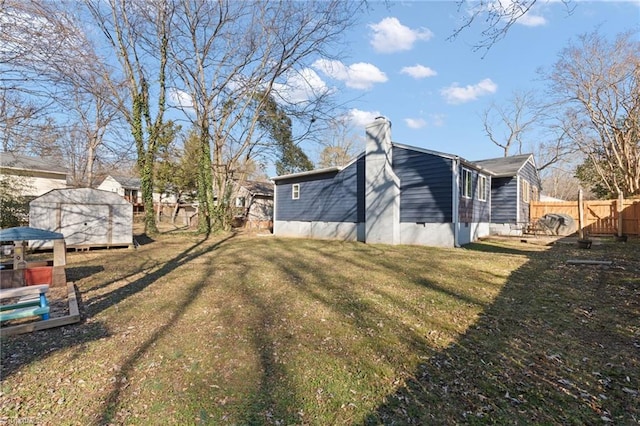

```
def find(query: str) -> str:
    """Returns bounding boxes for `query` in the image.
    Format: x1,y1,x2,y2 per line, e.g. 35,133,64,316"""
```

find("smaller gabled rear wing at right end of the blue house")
475,154,541,235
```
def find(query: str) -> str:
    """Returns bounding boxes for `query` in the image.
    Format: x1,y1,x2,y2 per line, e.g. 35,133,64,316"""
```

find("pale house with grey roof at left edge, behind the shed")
0,152,67,198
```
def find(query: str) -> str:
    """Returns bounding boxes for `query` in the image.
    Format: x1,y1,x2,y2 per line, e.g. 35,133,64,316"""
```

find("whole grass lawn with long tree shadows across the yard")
0,233,640,425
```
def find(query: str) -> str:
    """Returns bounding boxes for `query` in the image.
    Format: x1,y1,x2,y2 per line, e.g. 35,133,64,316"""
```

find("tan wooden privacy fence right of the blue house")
529,200,640,235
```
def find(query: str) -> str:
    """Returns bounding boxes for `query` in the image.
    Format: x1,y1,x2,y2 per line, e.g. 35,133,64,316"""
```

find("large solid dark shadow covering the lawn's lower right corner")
364,240,640,425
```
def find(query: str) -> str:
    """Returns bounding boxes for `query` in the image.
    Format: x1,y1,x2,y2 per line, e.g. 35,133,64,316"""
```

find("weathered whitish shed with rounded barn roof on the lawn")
29,188,133,248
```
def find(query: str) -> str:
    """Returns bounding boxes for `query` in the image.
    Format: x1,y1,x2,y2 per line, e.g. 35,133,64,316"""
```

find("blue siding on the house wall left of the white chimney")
275,161,364,223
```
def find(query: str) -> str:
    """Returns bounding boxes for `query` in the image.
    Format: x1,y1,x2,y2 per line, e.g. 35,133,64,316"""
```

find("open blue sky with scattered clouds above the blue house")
304,0,640,160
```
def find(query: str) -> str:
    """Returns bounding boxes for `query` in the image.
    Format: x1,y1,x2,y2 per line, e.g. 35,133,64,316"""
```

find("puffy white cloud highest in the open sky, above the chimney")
369,18,433,53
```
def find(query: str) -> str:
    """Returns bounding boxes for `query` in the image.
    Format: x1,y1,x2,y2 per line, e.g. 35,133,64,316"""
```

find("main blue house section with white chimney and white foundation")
273,117,492,247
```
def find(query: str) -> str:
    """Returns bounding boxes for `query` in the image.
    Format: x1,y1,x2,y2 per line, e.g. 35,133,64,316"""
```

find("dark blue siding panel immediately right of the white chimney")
393,147,453,223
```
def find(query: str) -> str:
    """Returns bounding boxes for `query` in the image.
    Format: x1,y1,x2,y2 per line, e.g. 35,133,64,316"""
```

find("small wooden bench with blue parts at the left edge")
0,284,49,321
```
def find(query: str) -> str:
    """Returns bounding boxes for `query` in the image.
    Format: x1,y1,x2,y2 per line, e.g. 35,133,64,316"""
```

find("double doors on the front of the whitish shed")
60,204,111,245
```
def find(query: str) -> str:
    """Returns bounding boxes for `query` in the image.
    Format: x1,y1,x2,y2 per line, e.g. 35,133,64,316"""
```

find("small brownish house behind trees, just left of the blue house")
234,181,273,229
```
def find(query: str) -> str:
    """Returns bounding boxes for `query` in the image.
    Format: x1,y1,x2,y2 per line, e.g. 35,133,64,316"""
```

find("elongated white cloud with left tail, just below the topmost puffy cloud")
313,59,388,90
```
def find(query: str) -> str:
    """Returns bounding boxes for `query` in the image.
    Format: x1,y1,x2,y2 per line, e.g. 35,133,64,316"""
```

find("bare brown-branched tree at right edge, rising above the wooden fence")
548,31,640,195
